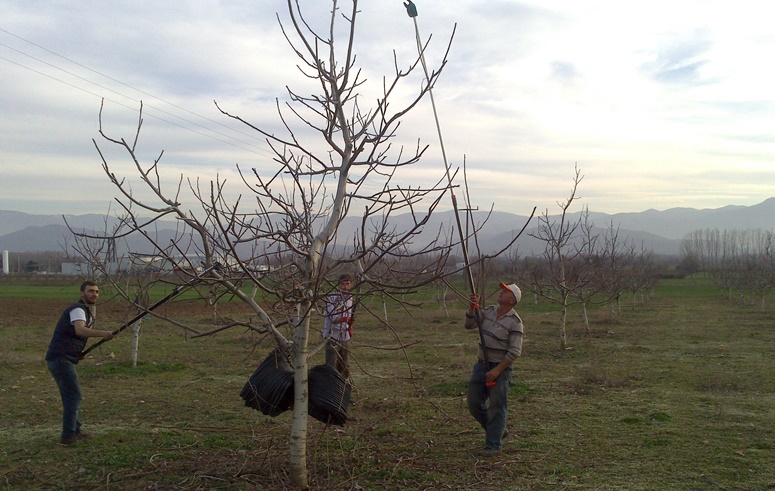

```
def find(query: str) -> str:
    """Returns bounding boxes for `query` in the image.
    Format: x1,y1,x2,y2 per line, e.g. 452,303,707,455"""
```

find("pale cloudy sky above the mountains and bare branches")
0,0,775,219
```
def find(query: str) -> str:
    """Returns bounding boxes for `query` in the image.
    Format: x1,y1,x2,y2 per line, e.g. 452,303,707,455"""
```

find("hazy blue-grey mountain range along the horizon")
0,198,775,256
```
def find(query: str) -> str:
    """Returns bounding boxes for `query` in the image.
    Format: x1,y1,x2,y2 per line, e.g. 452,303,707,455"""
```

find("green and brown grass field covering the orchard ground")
0,280,775,491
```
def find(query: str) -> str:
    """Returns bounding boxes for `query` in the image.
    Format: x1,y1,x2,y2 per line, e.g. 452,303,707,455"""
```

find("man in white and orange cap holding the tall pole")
465,283,524,457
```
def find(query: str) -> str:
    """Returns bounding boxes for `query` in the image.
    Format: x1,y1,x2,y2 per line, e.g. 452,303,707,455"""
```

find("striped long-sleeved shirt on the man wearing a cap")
465,305,524,363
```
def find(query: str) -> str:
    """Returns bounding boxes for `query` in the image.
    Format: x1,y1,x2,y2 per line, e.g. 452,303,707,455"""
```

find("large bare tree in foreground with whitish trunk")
65,0,516,487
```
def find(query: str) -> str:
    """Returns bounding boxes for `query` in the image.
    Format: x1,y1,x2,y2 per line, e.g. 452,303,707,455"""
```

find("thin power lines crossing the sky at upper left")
0,27,272,160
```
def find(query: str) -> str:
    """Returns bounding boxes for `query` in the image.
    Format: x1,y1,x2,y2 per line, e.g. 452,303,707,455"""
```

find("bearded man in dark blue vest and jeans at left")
46,281,113,445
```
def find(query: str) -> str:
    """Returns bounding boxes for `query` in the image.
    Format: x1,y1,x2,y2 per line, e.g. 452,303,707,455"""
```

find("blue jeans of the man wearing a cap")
468,363,513,450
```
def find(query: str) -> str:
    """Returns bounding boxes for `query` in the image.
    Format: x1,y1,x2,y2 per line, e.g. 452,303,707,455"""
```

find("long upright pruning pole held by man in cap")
404,0,495,387
